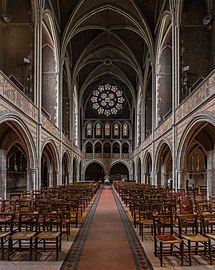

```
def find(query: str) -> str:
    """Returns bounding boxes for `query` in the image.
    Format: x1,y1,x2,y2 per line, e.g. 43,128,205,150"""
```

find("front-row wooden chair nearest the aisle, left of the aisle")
36,212,63,260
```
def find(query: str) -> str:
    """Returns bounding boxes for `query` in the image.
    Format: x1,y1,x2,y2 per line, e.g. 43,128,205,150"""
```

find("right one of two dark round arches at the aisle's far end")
110,162,129,182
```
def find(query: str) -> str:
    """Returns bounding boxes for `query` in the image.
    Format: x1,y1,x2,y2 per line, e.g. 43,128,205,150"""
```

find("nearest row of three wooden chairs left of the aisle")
0,212,63,260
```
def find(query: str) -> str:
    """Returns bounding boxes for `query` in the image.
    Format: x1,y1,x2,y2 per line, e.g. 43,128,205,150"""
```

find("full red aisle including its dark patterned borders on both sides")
61,186,153,270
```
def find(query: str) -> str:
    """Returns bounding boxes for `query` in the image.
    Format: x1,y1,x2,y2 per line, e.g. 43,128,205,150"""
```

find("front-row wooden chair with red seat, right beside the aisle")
153,213,184,266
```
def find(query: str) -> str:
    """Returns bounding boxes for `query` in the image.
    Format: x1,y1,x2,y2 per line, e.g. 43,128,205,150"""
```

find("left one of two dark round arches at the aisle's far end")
85,162,104,182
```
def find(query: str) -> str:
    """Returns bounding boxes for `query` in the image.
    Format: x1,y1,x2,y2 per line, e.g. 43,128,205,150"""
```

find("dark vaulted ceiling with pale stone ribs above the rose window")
46,0,168,112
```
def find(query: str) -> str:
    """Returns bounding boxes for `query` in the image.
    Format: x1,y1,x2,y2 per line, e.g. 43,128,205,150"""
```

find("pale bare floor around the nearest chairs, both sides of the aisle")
0,190,215,270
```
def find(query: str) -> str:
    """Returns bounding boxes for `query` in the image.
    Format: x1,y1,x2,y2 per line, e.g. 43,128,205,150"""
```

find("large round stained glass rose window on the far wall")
91,83,125,117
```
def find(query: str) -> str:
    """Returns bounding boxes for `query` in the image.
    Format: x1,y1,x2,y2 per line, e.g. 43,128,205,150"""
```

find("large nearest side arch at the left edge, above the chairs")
0,120,36,198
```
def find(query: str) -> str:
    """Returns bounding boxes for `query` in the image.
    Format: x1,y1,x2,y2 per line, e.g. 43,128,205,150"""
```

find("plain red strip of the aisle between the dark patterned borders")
78,186,136,270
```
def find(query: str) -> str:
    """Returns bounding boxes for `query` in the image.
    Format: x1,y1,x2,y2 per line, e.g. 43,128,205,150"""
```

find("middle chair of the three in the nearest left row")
8,212,38,260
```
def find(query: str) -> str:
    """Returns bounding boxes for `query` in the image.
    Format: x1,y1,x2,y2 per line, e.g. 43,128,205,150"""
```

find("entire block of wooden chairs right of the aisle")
115,183,215,266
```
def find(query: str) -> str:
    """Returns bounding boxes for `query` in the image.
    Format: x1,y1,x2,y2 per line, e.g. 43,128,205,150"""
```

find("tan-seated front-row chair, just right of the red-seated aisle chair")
177,214,212,265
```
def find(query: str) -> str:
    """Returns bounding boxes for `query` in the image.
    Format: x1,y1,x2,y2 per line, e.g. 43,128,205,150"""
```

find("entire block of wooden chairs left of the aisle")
0,183,99,260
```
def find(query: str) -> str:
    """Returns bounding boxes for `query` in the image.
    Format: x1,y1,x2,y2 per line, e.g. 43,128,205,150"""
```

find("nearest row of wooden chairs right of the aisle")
153,213,215,266
